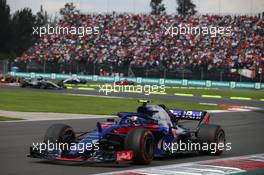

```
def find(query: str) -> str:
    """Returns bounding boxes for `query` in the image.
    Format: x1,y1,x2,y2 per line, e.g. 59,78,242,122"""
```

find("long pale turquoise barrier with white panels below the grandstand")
10,72,264,89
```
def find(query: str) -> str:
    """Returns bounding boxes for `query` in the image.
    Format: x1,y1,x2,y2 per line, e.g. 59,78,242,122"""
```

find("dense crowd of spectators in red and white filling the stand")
19,13,264,74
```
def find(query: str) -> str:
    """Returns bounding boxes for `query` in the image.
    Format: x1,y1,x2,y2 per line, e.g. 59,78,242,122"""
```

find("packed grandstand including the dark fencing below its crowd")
14,13,264,81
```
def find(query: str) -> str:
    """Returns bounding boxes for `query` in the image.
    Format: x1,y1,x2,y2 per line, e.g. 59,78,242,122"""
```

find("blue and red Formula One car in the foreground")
29,101,225,164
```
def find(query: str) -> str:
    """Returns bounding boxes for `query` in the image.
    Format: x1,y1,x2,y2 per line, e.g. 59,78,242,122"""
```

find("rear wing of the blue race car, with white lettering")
169,109,210,124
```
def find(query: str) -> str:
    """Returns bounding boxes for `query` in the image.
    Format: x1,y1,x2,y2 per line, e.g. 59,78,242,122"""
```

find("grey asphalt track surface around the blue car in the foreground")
0,87,264,175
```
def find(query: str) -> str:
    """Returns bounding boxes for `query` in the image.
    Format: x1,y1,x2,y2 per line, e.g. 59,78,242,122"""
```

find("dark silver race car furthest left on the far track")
20,77,63,89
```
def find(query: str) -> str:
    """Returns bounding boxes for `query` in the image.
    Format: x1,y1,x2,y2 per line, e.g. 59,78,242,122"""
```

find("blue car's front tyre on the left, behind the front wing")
44,124,76,144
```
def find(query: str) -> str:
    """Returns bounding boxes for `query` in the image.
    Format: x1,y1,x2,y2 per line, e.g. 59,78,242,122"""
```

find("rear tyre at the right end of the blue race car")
197,124,226,155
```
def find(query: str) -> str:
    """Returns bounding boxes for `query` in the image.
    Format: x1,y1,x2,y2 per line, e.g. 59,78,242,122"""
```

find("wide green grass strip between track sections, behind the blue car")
0,89,223,115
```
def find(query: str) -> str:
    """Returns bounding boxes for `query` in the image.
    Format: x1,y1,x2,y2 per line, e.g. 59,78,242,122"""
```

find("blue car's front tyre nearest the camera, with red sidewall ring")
125,128,156,164
